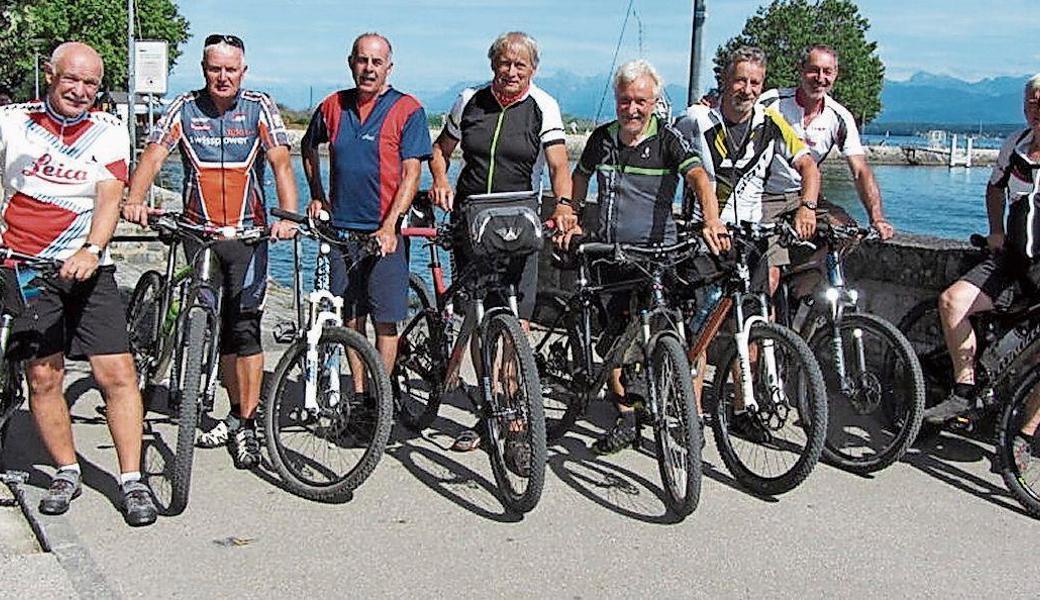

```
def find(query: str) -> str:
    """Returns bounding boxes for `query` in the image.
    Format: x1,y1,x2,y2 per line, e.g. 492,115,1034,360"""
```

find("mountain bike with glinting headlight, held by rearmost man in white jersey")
774,221,925,473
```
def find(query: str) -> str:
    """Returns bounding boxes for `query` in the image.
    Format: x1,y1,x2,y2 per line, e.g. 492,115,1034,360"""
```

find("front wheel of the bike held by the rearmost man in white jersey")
809,313,925,473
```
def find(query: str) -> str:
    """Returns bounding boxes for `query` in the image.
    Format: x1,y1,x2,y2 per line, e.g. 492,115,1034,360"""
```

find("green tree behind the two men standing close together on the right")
714,0,885,123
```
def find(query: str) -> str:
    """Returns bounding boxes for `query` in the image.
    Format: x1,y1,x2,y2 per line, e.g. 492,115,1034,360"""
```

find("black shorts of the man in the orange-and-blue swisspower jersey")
184,239,267,357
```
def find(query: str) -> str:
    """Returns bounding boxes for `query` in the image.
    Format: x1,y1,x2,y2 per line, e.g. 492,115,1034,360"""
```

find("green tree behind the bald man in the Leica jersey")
0,0,188,98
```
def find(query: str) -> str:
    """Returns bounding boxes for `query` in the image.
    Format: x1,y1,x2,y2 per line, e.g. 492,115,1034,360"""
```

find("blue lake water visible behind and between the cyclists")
159,157,990,285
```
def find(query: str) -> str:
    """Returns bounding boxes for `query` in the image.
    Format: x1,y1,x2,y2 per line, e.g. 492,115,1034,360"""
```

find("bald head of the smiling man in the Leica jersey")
44,42,105,119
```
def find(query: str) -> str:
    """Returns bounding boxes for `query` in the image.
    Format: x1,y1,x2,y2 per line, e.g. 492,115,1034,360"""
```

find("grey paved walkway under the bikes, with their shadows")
0,274,1040,598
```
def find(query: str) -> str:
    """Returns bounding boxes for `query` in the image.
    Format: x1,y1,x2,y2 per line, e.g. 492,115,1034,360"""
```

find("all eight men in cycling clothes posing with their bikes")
0,31,1040,525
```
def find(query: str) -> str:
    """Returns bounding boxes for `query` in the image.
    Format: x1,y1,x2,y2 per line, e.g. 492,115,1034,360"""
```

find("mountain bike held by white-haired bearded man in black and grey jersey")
532,239,703,517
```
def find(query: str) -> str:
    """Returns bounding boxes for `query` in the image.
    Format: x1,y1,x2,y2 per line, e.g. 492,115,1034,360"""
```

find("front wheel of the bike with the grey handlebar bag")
480,313,546,513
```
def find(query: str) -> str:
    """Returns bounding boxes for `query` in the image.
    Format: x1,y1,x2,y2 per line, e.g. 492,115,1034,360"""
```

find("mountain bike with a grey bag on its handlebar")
392,192,546,513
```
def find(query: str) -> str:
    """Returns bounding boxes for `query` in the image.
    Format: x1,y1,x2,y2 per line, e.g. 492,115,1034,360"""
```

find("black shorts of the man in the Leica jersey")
5,265,130,360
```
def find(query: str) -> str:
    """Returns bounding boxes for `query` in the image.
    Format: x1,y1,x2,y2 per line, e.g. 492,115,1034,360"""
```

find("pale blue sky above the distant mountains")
162,0,1040,105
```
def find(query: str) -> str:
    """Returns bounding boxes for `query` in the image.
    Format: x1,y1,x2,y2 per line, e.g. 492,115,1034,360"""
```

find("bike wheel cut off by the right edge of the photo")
996,366,1040,518
